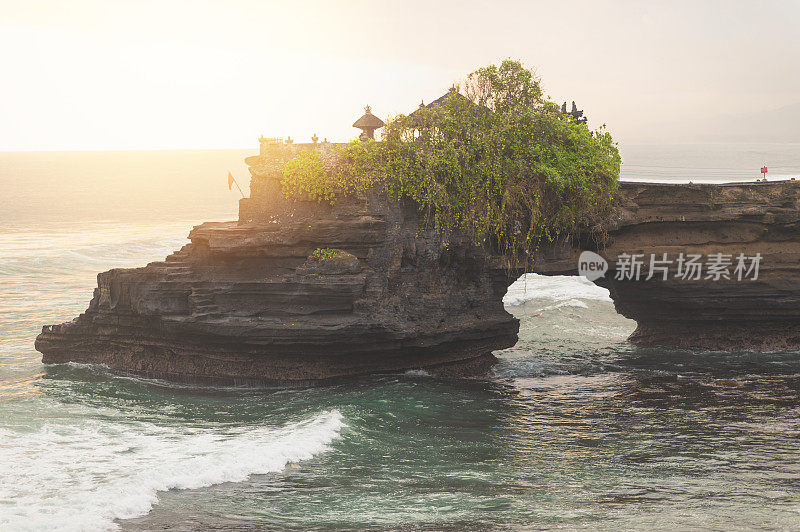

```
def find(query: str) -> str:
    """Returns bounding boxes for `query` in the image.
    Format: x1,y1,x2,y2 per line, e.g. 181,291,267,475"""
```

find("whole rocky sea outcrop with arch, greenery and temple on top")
36,62,800,383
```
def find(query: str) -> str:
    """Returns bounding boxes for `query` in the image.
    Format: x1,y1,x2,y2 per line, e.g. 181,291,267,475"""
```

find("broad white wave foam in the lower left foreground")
0,410,345,530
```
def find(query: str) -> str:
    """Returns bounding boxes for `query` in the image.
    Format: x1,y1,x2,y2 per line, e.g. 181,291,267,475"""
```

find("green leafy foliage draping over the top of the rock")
283,60,620,264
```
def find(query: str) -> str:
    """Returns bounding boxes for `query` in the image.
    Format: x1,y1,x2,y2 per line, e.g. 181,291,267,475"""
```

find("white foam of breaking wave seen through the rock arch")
503,273,611,308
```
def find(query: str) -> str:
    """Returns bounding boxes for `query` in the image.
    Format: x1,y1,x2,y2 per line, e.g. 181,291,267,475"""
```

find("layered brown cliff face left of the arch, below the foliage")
36,183,518,382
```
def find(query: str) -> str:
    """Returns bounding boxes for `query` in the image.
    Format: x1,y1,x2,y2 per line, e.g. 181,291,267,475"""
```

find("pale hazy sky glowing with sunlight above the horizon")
0,0,800,150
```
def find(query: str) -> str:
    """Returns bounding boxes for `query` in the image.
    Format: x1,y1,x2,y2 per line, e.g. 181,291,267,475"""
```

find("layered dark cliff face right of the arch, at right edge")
597,181,800,350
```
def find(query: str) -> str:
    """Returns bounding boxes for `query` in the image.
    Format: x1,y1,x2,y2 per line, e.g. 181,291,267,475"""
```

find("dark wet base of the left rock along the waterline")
36,326,506,386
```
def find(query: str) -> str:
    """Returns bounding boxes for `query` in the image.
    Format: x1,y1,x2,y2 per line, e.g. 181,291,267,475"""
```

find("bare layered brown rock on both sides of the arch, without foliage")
36,175,800,383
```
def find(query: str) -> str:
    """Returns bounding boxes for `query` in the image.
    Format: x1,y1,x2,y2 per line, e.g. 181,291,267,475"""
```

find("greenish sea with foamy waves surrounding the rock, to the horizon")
0,144,800,531
